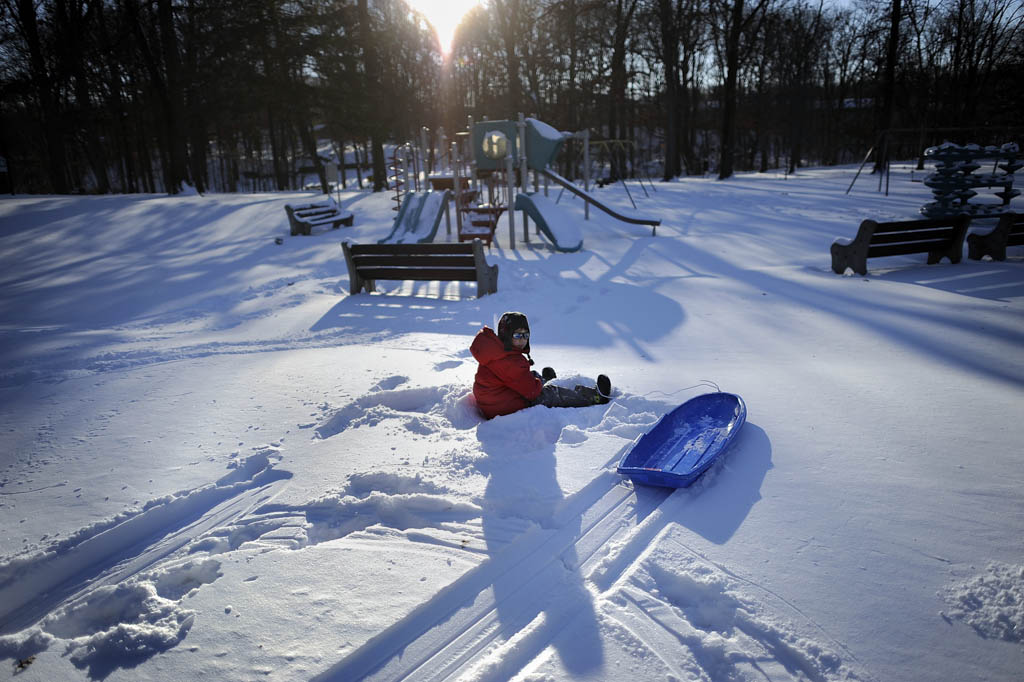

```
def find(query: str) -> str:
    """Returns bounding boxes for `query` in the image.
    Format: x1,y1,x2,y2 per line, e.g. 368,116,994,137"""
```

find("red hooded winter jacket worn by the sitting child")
469,327,544,419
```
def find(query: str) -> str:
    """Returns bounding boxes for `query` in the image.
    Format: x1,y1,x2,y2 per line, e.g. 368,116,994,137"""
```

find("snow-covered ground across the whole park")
0,167,1024,682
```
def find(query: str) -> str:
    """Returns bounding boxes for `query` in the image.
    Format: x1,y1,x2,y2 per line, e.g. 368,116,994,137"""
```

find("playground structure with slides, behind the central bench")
381,114,660,252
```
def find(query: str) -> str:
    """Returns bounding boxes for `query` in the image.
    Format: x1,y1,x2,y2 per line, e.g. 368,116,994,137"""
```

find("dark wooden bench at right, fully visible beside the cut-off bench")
831,215,971,275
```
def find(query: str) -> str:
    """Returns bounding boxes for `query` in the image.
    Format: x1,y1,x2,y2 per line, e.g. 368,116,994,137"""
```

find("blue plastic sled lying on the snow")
617,393,746,487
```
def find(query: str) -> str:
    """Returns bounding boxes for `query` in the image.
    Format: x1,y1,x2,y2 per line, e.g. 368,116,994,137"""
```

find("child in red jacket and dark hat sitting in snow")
469,312,611,419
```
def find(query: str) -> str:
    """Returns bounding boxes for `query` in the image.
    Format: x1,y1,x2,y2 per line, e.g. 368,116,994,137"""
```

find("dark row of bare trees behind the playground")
0,0,1024,194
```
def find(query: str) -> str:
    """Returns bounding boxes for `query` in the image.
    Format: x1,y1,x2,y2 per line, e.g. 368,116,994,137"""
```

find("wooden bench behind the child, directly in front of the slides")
341,240,498,298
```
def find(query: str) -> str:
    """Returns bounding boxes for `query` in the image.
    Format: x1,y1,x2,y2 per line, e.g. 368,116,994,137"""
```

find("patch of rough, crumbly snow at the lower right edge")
940,562,1024,642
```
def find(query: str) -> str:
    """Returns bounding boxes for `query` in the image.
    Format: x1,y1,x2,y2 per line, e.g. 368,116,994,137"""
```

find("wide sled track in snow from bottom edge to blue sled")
314,473,671,682
